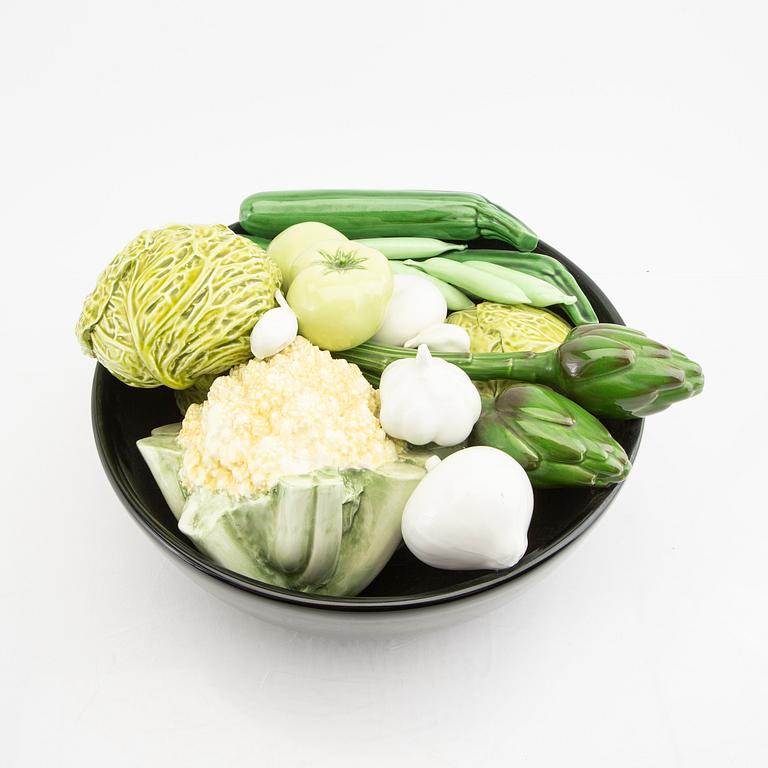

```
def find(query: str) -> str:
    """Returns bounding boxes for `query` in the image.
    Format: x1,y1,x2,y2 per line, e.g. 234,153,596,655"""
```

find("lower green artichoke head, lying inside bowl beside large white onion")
469,382,630,488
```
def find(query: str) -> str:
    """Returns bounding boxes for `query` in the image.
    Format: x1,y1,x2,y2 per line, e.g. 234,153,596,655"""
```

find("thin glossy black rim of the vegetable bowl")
91,237,644,613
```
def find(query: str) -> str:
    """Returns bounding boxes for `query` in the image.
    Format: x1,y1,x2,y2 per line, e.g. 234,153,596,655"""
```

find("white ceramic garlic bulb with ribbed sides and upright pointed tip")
379,344,480,446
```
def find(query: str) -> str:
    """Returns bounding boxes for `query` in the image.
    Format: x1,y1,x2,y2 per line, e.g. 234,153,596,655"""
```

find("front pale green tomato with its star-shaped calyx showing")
287,242,392,351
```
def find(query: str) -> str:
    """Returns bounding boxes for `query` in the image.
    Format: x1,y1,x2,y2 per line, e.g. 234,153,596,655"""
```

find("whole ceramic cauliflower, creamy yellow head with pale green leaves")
138,337,424,595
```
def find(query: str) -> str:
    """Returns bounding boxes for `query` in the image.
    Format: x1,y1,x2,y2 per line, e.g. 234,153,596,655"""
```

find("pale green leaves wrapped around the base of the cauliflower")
138,434,424,595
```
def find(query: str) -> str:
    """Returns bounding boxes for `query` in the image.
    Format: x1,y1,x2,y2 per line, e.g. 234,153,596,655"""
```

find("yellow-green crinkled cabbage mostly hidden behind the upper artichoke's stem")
446,301,570,352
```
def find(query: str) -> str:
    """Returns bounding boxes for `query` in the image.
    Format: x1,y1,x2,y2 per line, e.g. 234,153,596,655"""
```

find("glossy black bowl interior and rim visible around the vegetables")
91,232,643,613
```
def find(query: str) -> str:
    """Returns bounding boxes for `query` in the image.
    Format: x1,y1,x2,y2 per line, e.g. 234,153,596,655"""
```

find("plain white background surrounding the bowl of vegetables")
0,0,768,768
